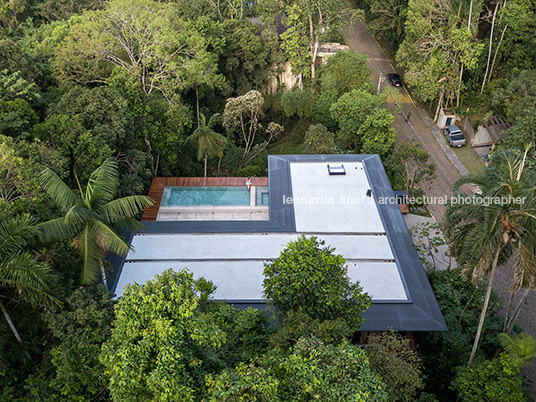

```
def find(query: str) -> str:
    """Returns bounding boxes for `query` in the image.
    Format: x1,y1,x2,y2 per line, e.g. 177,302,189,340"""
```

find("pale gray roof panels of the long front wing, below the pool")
116,233,407,301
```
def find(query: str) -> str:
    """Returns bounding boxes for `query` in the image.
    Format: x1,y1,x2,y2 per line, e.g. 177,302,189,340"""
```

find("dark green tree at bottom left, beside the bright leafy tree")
25,285,113,400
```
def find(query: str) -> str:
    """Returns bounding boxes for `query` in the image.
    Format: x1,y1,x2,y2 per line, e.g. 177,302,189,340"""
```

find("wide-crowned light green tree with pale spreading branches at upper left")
55,0,212,101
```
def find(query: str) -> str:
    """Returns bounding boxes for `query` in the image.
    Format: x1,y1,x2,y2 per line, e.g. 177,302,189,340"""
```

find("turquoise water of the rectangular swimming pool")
160,186,268,207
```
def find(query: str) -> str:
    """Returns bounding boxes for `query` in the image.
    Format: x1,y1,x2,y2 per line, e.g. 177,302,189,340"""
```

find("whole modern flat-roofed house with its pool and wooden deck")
112,154,446,331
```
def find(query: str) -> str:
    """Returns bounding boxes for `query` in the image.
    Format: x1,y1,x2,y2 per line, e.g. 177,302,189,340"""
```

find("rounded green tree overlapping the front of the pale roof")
263,235,370,330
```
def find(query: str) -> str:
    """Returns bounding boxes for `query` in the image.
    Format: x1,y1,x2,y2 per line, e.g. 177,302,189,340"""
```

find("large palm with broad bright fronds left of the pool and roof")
39,159,153,285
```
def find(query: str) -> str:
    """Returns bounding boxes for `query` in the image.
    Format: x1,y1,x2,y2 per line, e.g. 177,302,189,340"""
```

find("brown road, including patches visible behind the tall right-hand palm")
342,16,536,401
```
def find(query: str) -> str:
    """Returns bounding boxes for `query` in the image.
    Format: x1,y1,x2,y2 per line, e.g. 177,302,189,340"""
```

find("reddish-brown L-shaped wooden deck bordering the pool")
141,177,268,221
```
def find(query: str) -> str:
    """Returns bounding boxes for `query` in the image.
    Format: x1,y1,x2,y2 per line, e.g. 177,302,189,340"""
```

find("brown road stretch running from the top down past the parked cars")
343,22,460,221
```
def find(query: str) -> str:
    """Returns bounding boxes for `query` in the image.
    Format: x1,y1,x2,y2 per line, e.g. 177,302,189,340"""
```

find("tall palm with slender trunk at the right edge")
445,150,536,364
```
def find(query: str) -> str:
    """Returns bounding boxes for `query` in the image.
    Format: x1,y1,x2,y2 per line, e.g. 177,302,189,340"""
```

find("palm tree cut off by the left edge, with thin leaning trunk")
0,216,60,344
